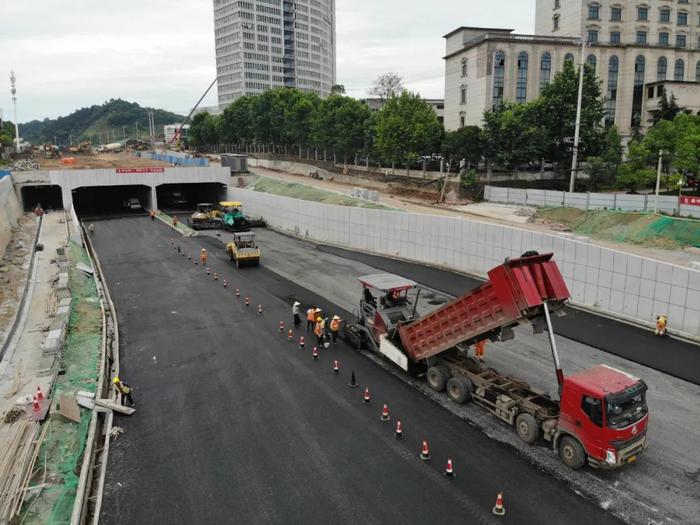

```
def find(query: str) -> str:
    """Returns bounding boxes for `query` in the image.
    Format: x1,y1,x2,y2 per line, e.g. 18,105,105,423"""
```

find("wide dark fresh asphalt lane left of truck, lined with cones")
93,218,617,524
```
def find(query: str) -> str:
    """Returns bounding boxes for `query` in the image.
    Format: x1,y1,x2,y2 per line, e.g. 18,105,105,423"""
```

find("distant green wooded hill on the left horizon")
20,98,185,145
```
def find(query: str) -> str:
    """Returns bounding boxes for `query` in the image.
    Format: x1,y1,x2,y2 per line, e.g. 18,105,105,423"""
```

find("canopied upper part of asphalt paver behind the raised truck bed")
358,273,420,342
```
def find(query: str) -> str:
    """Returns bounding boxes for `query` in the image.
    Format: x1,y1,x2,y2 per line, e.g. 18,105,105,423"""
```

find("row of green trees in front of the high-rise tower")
190,88,442,165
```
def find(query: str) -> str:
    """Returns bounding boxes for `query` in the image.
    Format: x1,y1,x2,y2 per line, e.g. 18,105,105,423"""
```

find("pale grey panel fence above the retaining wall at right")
484,186,700,218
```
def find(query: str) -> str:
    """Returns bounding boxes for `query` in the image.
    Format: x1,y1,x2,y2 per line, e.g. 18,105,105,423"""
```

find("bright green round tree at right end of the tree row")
375,91,443,168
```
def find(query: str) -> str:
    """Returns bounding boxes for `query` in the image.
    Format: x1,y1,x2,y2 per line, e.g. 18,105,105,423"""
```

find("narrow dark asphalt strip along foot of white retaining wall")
319,245,700,385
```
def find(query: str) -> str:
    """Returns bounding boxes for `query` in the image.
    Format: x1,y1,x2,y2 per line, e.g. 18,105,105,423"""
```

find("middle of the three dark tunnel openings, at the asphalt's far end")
73,185,151,218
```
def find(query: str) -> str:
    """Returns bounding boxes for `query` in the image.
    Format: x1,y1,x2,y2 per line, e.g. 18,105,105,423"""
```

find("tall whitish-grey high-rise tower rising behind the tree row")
214,0,336,109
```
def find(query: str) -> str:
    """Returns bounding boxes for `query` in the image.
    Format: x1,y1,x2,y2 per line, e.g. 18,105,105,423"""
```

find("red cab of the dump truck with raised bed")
555,365,649,469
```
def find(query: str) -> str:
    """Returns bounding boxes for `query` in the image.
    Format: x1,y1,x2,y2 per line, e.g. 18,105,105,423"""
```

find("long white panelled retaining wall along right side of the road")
229,188,700,338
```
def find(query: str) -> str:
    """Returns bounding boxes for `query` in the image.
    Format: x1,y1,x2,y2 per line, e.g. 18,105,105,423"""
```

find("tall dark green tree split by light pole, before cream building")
534,61,605,167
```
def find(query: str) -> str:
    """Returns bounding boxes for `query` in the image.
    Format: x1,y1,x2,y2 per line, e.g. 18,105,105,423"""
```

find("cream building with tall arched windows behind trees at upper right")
445,0,700,136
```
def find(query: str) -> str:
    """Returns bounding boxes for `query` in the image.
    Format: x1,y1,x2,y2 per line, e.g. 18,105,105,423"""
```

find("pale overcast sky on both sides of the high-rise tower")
0,0,535,122
